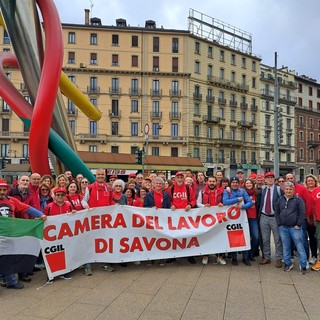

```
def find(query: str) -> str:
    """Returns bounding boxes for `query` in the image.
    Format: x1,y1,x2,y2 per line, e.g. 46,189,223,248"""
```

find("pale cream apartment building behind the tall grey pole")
259,64,296,175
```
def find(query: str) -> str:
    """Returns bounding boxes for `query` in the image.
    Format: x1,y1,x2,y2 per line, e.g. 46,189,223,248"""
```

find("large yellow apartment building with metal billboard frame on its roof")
1,10,264,175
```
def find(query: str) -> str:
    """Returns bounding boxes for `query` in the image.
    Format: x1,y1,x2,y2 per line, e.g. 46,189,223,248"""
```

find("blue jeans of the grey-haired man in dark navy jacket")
279,226,307,268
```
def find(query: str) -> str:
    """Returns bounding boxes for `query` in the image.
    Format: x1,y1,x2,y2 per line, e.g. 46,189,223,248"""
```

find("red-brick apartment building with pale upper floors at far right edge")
295,75,320,181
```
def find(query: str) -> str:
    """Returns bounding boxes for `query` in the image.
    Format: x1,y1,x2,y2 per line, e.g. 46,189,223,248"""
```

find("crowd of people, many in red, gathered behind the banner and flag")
0,169,320,289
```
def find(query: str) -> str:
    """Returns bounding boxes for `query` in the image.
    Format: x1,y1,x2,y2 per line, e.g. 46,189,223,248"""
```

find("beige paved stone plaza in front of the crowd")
0,255,320,320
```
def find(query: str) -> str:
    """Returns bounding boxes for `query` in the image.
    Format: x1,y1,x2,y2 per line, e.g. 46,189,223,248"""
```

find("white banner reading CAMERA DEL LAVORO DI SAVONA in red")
41,205,250,279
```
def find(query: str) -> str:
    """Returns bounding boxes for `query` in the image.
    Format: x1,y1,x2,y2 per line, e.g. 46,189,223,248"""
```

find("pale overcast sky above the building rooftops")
54,0,320,83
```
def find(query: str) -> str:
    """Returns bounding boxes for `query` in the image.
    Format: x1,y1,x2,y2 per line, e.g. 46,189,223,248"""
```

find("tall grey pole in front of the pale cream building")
273,52,280,178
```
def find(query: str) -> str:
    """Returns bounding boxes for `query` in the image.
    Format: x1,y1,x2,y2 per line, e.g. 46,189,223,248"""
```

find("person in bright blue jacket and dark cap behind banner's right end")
222,177,253,266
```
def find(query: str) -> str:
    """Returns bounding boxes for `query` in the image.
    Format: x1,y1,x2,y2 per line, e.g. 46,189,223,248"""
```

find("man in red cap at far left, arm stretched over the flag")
0,180,47,289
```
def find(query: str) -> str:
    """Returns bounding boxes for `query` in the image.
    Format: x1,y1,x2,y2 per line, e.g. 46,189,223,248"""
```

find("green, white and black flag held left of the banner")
0,216,43,274
